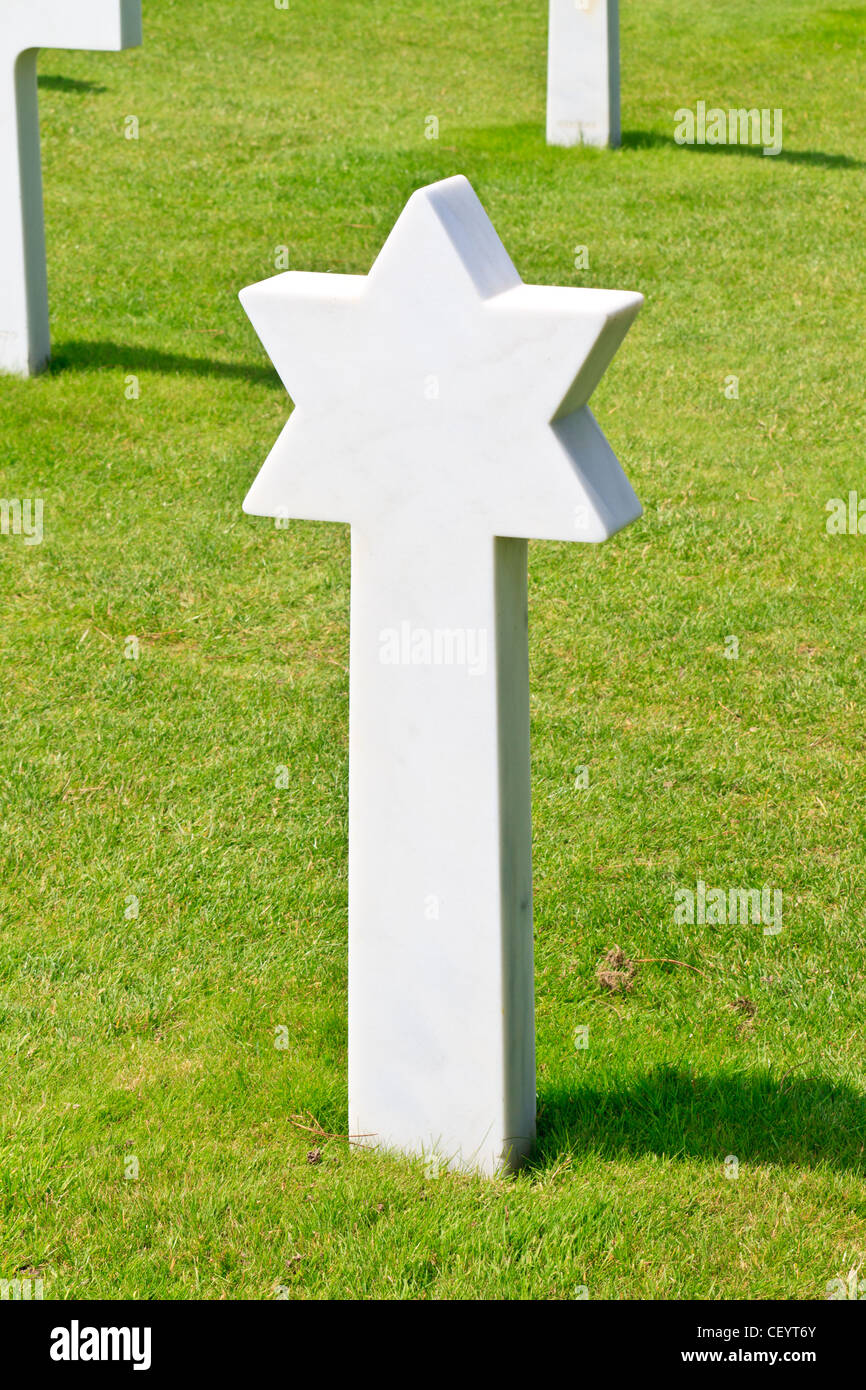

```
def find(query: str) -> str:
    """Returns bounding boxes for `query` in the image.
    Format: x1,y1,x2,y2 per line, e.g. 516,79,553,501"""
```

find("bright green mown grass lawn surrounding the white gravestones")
0,0,866,1298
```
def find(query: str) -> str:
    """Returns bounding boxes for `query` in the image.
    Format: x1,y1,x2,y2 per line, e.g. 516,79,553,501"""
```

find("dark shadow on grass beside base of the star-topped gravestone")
532,1066,866,1172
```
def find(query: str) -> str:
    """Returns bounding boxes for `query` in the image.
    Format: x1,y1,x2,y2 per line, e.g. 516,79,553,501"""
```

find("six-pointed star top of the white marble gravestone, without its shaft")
240,177,642,541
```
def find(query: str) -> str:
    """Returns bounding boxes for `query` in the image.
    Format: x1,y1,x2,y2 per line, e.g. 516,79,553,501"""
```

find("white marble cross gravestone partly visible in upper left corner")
0,0,142,377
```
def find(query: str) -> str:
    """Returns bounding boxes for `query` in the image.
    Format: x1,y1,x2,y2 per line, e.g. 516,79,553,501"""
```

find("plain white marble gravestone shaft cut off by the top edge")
548,0,620,147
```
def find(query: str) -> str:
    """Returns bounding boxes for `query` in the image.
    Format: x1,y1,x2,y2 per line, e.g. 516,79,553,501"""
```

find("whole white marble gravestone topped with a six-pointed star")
240,178,642,1173
